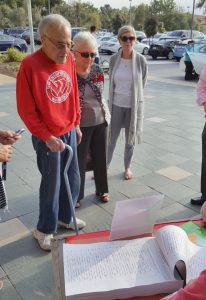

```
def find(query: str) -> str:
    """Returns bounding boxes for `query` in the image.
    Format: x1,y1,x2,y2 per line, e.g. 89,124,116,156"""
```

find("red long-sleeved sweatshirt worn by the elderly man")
16,49,80,141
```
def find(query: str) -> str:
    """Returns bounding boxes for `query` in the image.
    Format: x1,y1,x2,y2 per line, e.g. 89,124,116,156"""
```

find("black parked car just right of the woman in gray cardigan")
148,39,178,60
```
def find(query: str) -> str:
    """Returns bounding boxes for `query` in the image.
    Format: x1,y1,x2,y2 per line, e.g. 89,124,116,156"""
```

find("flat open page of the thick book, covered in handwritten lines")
63,237,175,296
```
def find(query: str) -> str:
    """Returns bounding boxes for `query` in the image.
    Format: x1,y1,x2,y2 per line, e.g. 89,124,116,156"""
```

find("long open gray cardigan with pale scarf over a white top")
109,50,148,145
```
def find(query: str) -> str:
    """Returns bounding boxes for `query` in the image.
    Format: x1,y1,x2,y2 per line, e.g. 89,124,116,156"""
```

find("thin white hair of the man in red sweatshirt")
38,14,71,36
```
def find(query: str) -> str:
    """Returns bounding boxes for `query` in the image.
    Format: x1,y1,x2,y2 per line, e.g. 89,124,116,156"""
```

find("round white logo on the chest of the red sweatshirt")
46,70,72,103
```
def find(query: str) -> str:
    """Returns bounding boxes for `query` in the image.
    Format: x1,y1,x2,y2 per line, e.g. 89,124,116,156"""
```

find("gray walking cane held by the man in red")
64,144,79,235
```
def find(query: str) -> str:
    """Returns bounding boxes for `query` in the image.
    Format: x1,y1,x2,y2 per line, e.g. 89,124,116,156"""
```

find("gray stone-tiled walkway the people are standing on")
0,68,204,300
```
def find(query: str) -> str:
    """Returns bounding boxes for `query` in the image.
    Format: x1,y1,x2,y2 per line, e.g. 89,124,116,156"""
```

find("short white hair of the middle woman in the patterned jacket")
73,31,97,51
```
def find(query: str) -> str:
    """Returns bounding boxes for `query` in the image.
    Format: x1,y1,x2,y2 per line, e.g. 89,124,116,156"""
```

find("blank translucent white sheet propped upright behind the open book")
109,195,164,240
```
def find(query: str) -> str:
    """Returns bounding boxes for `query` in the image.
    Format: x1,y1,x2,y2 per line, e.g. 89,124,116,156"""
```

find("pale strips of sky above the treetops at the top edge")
79,0,202,14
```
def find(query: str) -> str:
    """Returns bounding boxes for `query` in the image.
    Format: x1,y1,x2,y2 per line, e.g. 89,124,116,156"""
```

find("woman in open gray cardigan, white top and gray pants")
107,25,148,180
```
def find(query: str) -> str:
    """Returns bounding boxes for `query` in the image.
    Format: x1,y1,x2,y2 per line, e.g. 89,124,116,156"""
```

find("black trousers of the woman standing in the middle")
77,123,108,201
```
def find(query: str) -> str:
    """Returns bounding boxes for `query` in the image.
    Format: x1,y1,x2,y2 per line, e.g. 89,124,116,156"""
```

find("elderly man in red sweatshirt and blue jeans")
17,14,86,251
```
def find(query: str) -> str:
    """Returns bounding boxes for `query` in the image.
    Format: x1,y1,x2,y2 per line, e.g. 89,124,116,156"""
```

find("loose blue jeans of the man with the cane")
32,129,80,234
